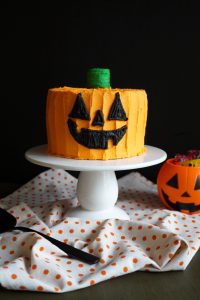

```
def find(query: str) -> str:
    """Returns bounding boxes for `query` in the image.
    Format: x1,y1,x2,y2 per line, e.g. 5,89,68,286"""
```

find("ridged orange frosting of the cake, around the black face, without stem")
46,87,148,160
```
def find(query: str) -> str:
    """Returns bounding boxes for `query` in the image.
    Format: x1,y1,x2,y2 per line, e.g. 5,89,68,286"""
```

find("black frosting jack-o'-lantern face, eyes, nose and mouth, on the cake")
67,93,127,149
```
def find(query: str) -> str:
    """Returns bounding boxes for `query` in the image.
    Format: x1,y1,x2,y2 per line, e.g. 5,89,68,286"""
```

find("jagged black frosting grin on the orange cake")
67,119,127,149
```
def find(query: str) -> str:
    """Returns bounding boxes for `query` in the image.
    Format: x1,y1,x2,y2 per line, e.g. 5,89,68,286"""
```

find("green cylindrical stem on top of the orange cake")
87,68,110,88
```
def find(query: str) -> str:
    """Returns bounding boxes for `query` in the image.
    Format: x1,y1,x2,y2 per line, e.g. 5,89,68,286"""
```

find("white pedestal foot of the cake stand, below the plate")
70,171,129,220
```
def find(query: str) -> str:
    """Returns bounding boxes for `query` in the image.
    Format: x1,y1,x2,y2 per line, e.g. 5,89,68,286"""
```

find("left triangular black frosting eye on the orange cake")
69,93,90,120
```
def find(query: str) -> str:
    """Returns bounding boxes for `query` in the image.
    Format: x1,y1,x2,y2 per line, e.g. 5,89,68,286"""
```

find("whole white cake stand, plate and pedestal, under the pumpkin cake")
25,145,167,220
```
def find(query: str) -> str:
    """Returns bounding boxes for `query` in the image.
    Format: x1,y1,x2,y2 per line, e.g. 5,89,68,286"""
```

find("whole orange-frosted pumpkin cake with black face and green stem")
46,69,148,160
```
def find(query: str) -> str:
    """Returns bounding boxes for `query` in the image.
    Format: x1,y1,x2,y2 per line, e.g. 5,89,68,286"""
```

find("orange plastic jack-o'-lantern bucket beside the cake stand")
157,159,200,214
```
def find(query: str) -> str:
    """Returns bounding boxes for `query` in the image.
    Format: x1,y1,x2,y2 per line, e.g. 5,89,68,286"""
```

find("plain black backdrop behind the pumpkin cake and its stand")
0,1,200,183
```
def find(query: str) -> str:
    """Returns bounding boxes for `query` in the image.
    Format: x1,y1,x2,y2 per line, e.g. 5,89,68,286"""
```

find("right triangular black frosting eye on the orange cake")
108,93,128,121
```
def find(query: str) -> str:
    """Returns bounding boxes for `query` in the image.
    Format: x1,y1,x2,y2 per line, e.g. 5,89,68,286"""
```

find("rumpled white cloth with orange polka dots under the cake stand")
0,170,200,293
